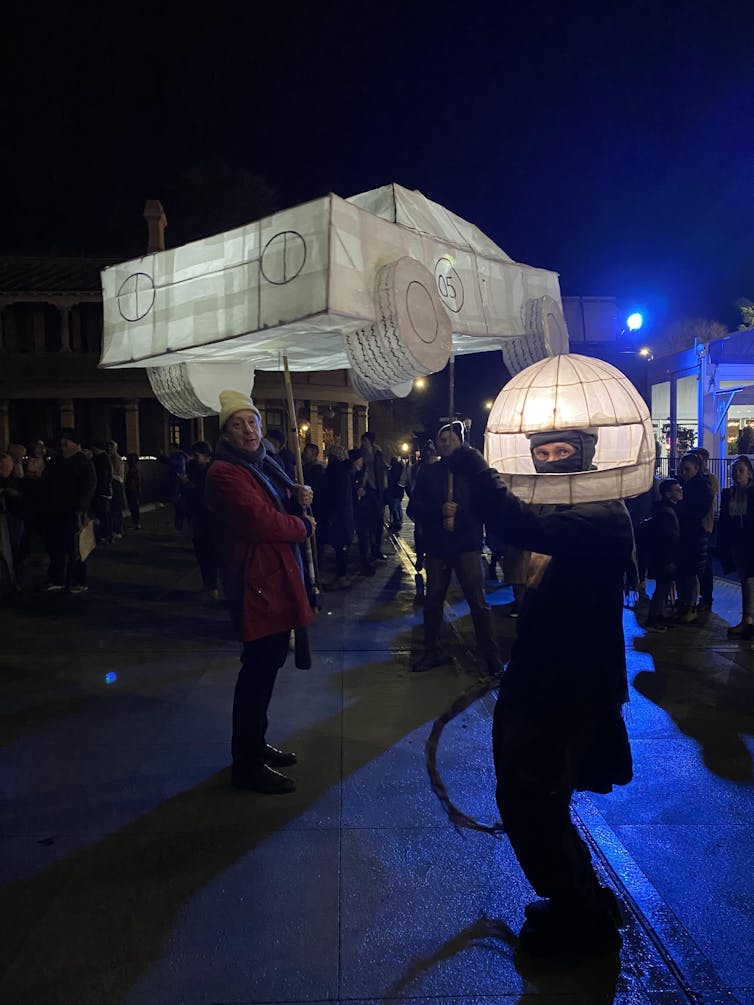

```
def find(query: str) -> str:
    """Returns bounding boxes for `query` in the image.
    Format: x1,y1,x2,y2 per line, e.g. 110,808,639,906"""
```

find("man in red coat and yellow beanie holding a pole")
204,391,315,794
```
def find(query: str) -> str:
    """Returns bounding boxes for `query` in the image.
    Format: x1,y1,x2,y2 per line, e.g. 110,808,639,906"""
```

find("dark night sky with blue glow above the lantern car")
0,0,754,326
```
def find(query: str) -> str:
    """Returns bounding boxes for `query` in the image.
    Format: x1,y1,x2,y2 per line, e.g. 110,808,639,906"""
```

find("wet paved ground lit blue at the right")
0,512,754,1005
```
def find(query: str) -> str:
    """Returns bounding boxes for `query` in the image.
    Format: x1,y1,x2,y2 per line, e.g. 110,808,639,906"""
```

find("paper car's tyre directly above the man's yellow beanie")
147,362,254,419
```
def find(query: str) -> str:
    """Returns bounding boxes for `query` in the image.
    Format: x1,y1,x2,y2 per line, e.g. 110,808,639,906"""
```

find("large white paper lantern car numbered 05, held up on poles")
100,185,560,410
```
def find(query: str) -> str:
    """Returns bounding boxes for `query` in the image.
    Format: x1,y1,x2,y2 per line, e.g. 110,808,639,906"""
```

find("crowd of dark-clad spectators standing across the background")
7,416,754,651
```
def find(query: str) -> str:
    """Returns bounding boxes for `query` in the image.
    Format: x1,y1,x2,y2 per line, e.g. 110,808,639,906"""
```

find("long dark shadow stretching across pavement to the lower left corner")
0,643,472,1005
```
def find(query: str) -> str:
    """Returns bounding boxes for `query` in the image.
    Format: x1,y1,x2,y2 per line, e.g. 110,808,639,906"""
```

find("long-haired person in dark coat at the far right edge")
717,454,754,638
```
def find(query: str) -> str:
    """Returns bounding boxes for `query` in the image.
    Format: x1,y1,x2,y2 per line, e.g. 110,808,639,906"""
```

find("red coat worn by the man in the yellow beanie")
204,459,314,642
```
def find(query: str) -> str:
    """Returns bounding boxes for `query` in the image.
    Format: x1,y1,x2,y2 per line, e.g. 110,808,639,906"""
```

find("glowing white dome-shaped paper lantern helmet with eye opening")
485,354,654,505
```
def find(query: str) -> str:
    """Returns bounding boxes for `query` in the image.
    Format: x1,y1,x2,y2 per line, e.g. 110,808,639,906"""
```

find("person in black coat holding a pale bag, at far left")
42,427,96,593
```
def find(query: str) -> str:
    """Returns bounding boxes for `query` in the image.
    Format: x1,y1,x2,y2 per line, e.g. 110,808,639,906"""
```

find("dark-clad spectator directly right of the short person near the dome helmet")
678,451,712,624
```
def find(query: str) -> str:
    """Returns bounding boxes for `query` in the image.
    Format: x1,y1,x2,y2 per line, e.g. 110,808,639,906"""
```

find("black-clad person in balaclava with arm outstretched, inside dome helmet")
449,429,633,958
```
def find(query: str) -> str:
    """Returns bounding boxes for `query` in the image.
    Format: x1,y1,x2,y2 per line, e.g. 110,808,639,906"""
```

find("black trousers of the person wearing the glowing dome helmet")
493,696,599,906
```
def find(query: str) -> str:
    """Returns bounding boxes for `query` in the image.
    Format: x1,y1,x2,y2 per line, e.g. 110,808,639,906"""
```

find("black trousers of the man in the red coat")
230,631,291,773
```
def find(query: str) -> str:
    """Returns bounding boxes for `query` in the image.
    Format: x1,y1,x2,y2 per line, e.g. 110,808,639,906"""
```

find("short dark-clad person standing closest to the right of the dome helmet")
639,478,684,631
